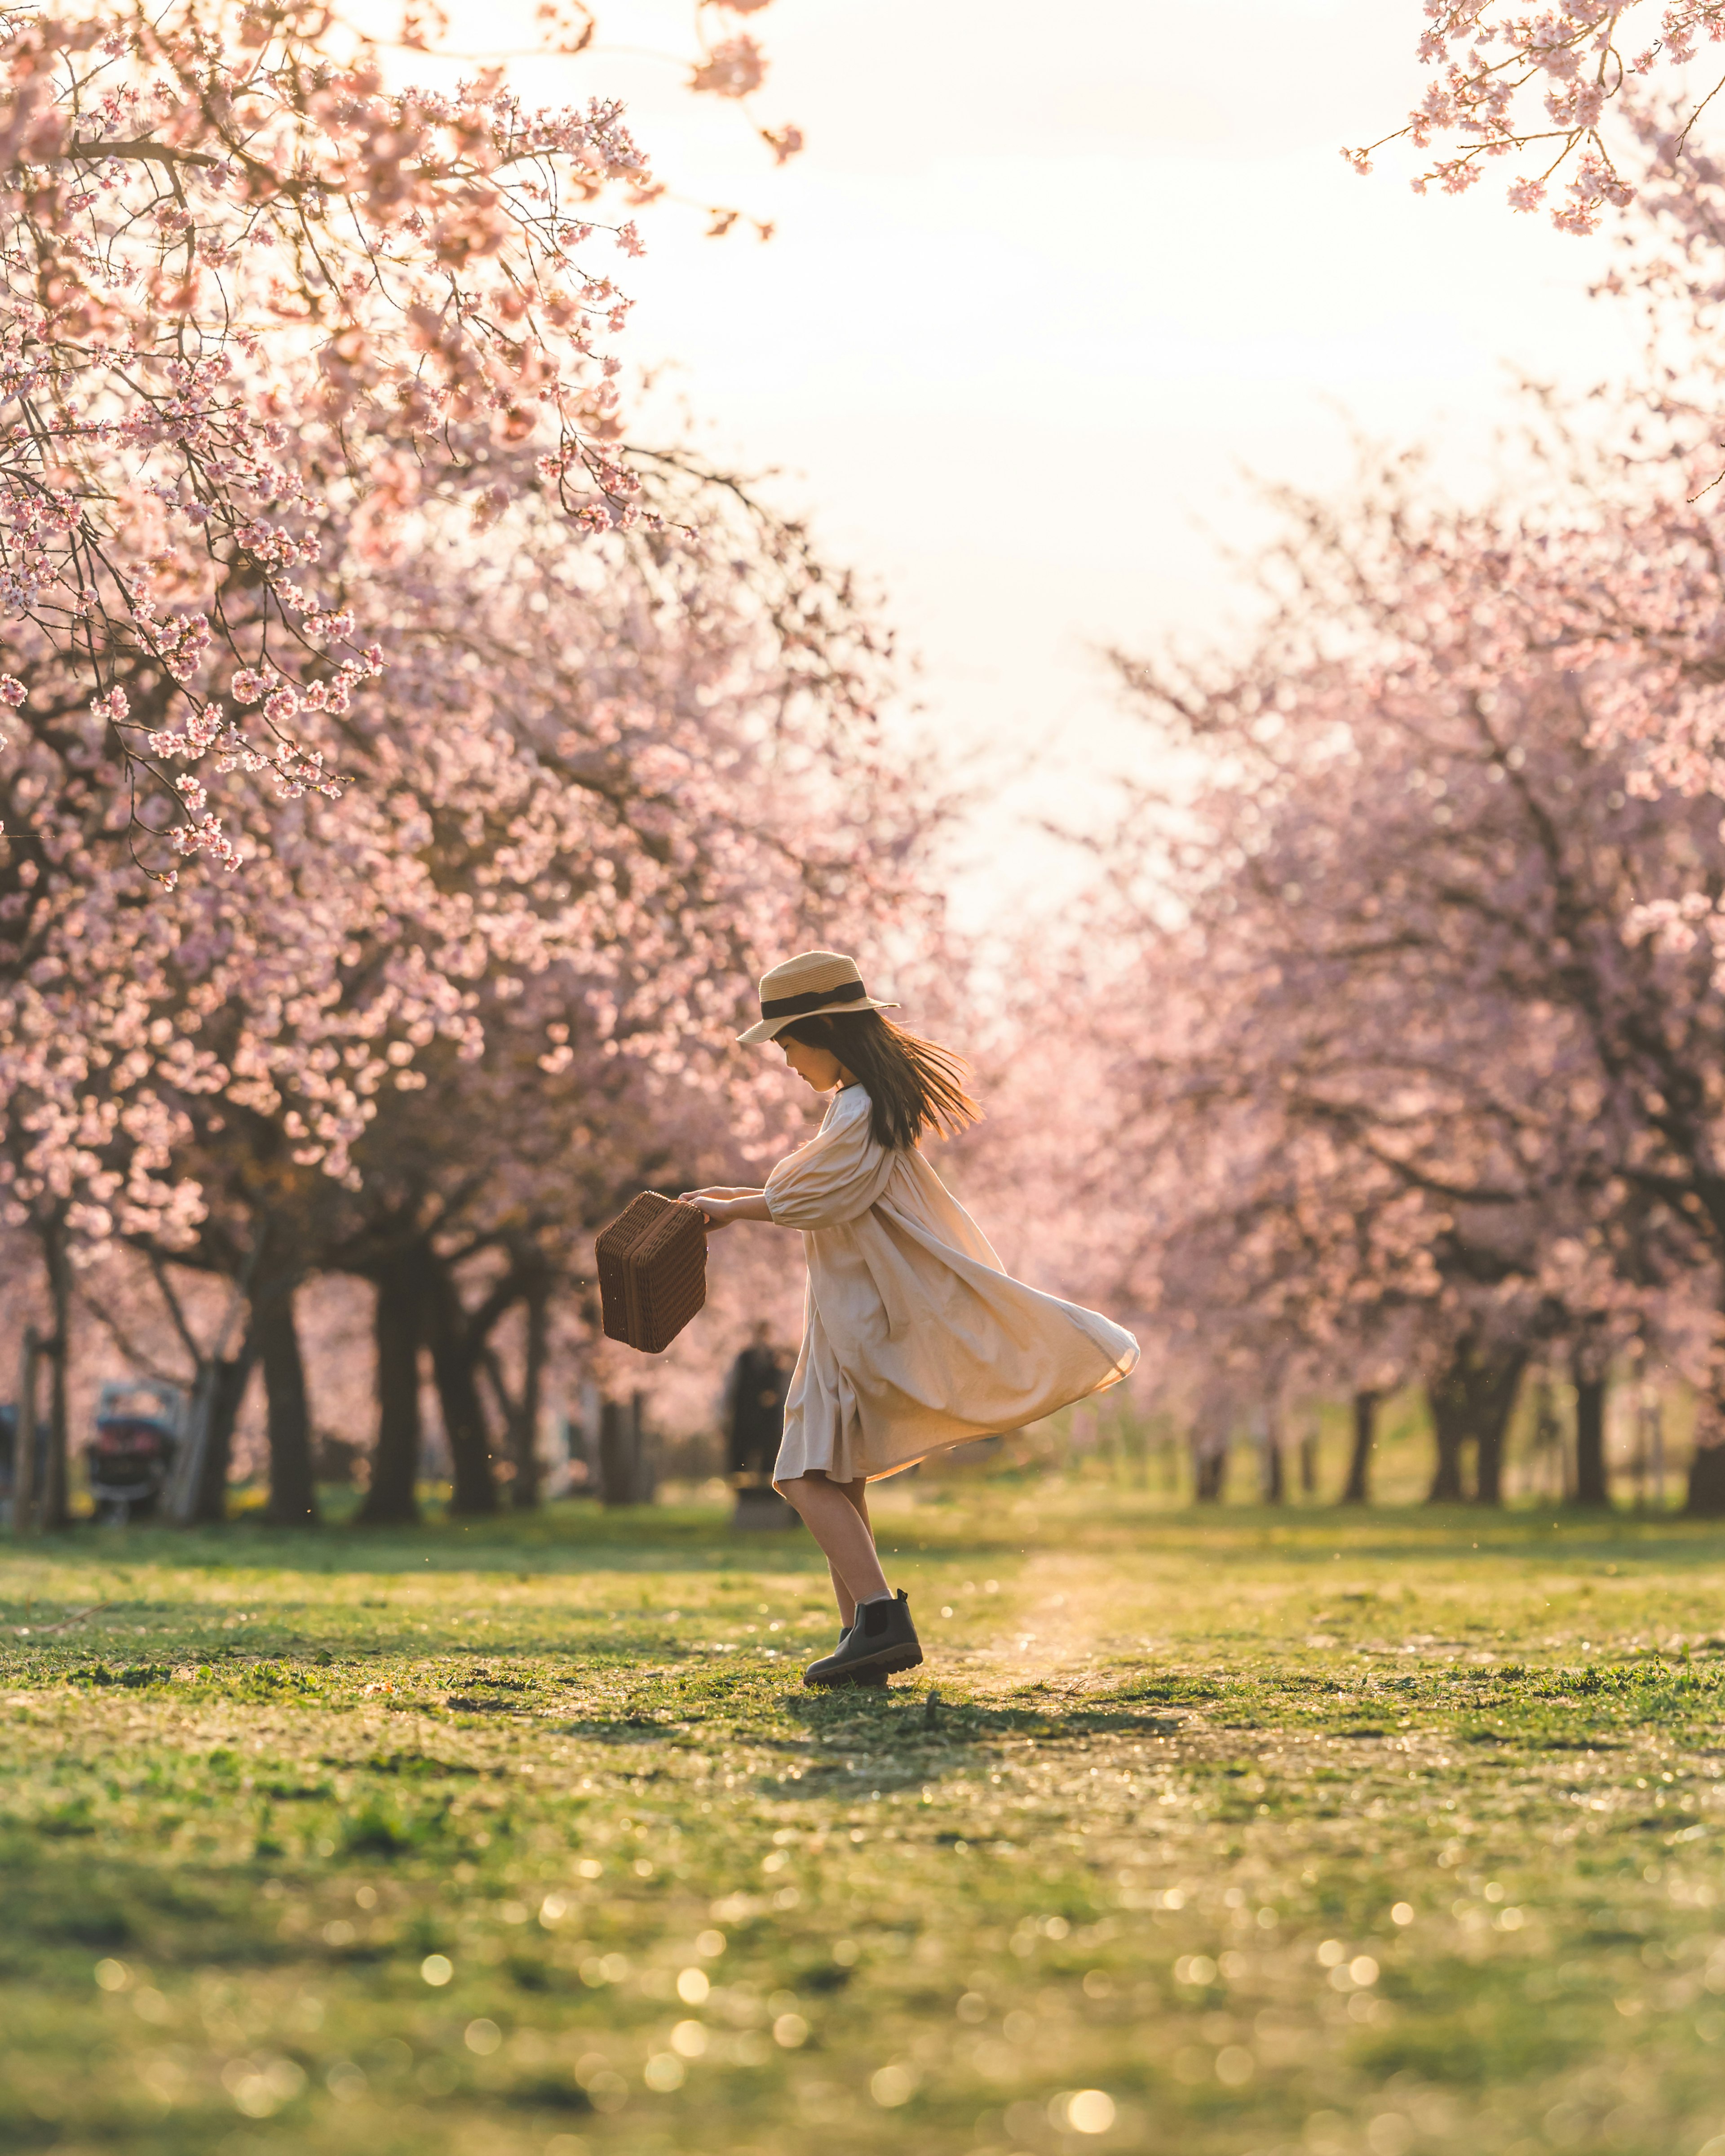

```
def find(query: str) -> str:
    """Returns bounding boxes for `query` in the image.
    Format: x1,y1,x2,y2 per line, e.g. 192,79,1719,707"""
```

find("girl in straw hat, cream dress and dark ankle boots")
686,951,1138,1684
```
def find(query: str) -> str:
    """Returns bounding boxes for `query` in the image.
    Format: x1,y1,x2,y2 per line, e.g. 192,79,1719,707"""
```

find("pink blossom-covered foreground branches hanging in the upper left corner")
0,0,651,867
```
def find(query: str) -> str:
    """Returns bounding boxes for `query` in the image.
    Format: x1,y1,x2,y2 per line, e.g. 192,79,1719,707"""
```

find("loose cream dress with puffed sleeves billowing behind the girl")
765,1085,1138,1483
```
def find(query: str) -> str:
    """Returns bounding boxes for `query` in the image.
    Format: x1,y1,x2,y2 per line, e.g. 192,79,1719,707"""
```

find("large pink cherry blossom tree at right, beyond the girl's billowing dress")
1087,450,1725,1511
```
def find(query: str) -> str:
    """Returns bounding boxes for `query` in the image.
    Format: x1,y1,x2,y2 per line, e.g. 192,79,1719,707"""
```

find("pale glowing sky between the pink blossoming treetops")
442,0,1630,912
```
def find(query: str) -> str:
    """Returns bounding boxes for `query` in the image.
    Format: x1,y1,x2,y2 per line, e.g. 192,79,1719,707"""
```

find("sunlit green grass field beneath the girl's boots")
0,1481,1725,2156
